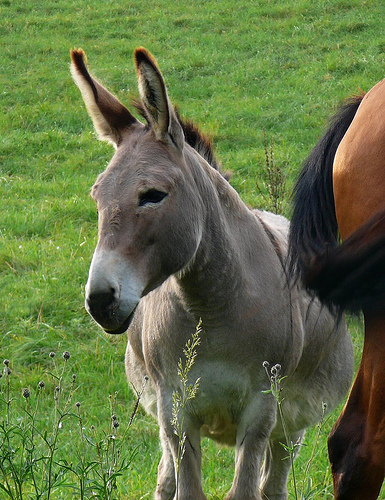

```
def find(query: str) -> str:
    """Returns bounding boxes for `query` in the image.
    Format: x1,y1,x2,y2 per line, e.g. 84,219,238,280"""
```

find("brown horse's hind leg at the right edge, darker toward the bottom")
328,311,385,500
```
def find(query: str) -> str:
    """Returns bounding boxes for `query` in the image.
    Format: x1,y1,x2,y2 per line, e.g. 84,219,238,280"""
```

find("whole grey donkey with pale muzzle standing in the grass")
72,48,352,500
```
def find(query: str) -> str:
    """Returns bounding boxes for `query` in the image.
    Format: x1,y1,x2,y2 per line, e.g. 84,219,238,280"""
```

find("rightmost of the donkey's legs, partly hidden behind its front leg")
262,431,305,500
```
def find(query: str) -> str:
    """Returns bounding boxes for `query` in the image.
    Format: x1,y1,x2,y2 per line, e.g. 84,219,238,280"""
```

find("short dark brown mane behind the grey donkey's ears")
132,99,228,176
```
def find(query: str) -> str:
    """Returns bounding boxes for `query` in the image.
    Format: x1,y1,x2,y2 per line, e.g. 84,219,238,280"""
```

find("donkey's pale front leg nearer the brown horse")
225,394,276,500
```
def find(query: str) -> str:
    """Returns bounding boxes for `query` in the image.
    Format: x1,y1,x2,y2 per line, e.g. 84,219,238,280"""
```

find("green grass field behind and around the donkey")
0,0,385,500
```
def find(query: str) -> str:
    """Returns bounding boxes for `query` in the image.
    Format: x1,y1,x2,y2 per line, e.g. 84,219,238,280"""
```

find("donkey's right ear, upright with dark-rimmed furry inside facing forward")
134,47,184,149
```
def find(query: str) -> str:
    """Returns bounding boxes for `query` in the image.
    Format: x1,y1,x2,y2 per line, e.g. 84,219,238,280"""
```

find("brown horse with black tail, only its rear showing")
290,81,385,500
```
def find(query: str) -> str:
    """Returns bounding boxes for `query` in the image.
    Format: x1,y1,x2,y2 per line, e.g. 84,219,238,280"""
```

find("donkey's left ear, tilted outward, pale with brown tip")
71,49,137,146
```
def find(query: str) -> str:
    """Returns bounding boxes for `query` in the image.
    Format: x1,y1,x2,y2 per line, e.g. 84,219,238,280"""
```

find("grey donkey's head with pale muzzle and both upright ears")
71,48,203,333
